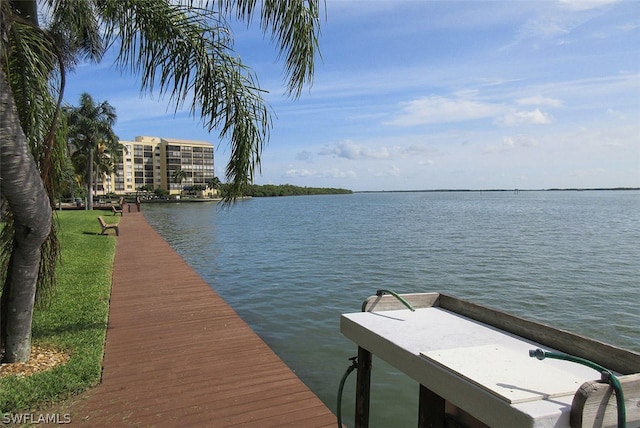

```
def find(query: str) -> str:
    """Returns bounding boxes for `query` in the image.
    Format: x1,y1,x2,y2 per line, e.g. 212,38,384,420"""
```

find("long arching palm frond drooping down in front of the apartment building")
102,0,271,201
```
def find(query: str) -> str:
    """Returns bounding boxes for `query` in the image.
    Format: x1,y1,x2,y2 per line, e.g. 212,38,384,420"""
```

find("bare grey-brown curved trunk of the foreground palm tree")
0,67,52,362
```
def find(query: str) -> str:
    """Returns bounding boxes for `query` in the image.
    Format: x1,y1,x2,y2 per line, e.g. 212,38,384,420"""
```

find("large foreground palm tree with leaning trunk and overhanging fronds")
0,0,319,361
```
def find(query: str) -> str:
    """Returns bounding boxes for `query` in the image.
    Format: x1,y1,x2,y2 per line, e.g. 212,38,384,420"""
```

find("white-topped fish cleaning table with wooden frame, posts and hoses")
340,293,640,428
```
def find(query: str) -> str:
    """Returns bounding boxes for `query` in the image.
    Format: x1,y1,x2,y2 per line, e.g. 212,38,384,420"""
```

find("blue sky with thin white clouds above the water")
57,0,640,191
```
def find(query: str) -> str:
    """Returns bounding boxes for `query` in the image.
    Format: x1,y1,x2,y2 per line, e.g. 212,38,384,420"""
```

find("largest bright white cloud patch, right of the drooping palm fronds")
384,96,503,126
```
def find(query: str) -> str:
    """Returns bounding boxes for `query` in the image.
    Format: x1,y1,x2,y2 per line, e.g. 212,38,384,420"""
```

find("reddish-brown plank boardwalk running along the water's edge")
66,212,336,428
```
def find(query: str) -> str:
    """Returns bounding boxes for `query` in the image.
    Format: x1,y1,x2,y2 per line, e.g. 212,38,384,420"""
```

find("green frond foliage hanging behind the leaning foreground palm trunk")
0,6,65,306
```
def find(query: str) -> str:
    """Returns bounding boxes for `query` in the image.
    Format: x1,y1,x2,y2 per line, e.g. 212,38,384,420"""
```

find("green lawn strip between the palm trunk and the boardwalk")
0,211,116,415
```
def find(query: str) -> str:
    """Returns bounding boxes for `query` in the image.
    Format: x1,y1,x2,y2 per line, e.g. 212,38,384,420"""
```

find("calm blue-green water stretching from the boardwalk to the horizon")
143,191,640,427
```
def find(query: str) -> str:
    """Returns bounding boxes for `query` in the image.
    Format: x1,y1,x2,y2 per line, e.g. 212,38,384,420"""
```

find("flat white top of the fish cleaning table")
340,307,600,428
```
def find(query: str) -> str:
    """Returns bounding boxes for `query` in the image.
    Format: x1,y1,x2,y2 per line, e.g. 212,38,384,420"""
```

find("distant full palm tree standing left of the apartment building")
64,92,120,210
